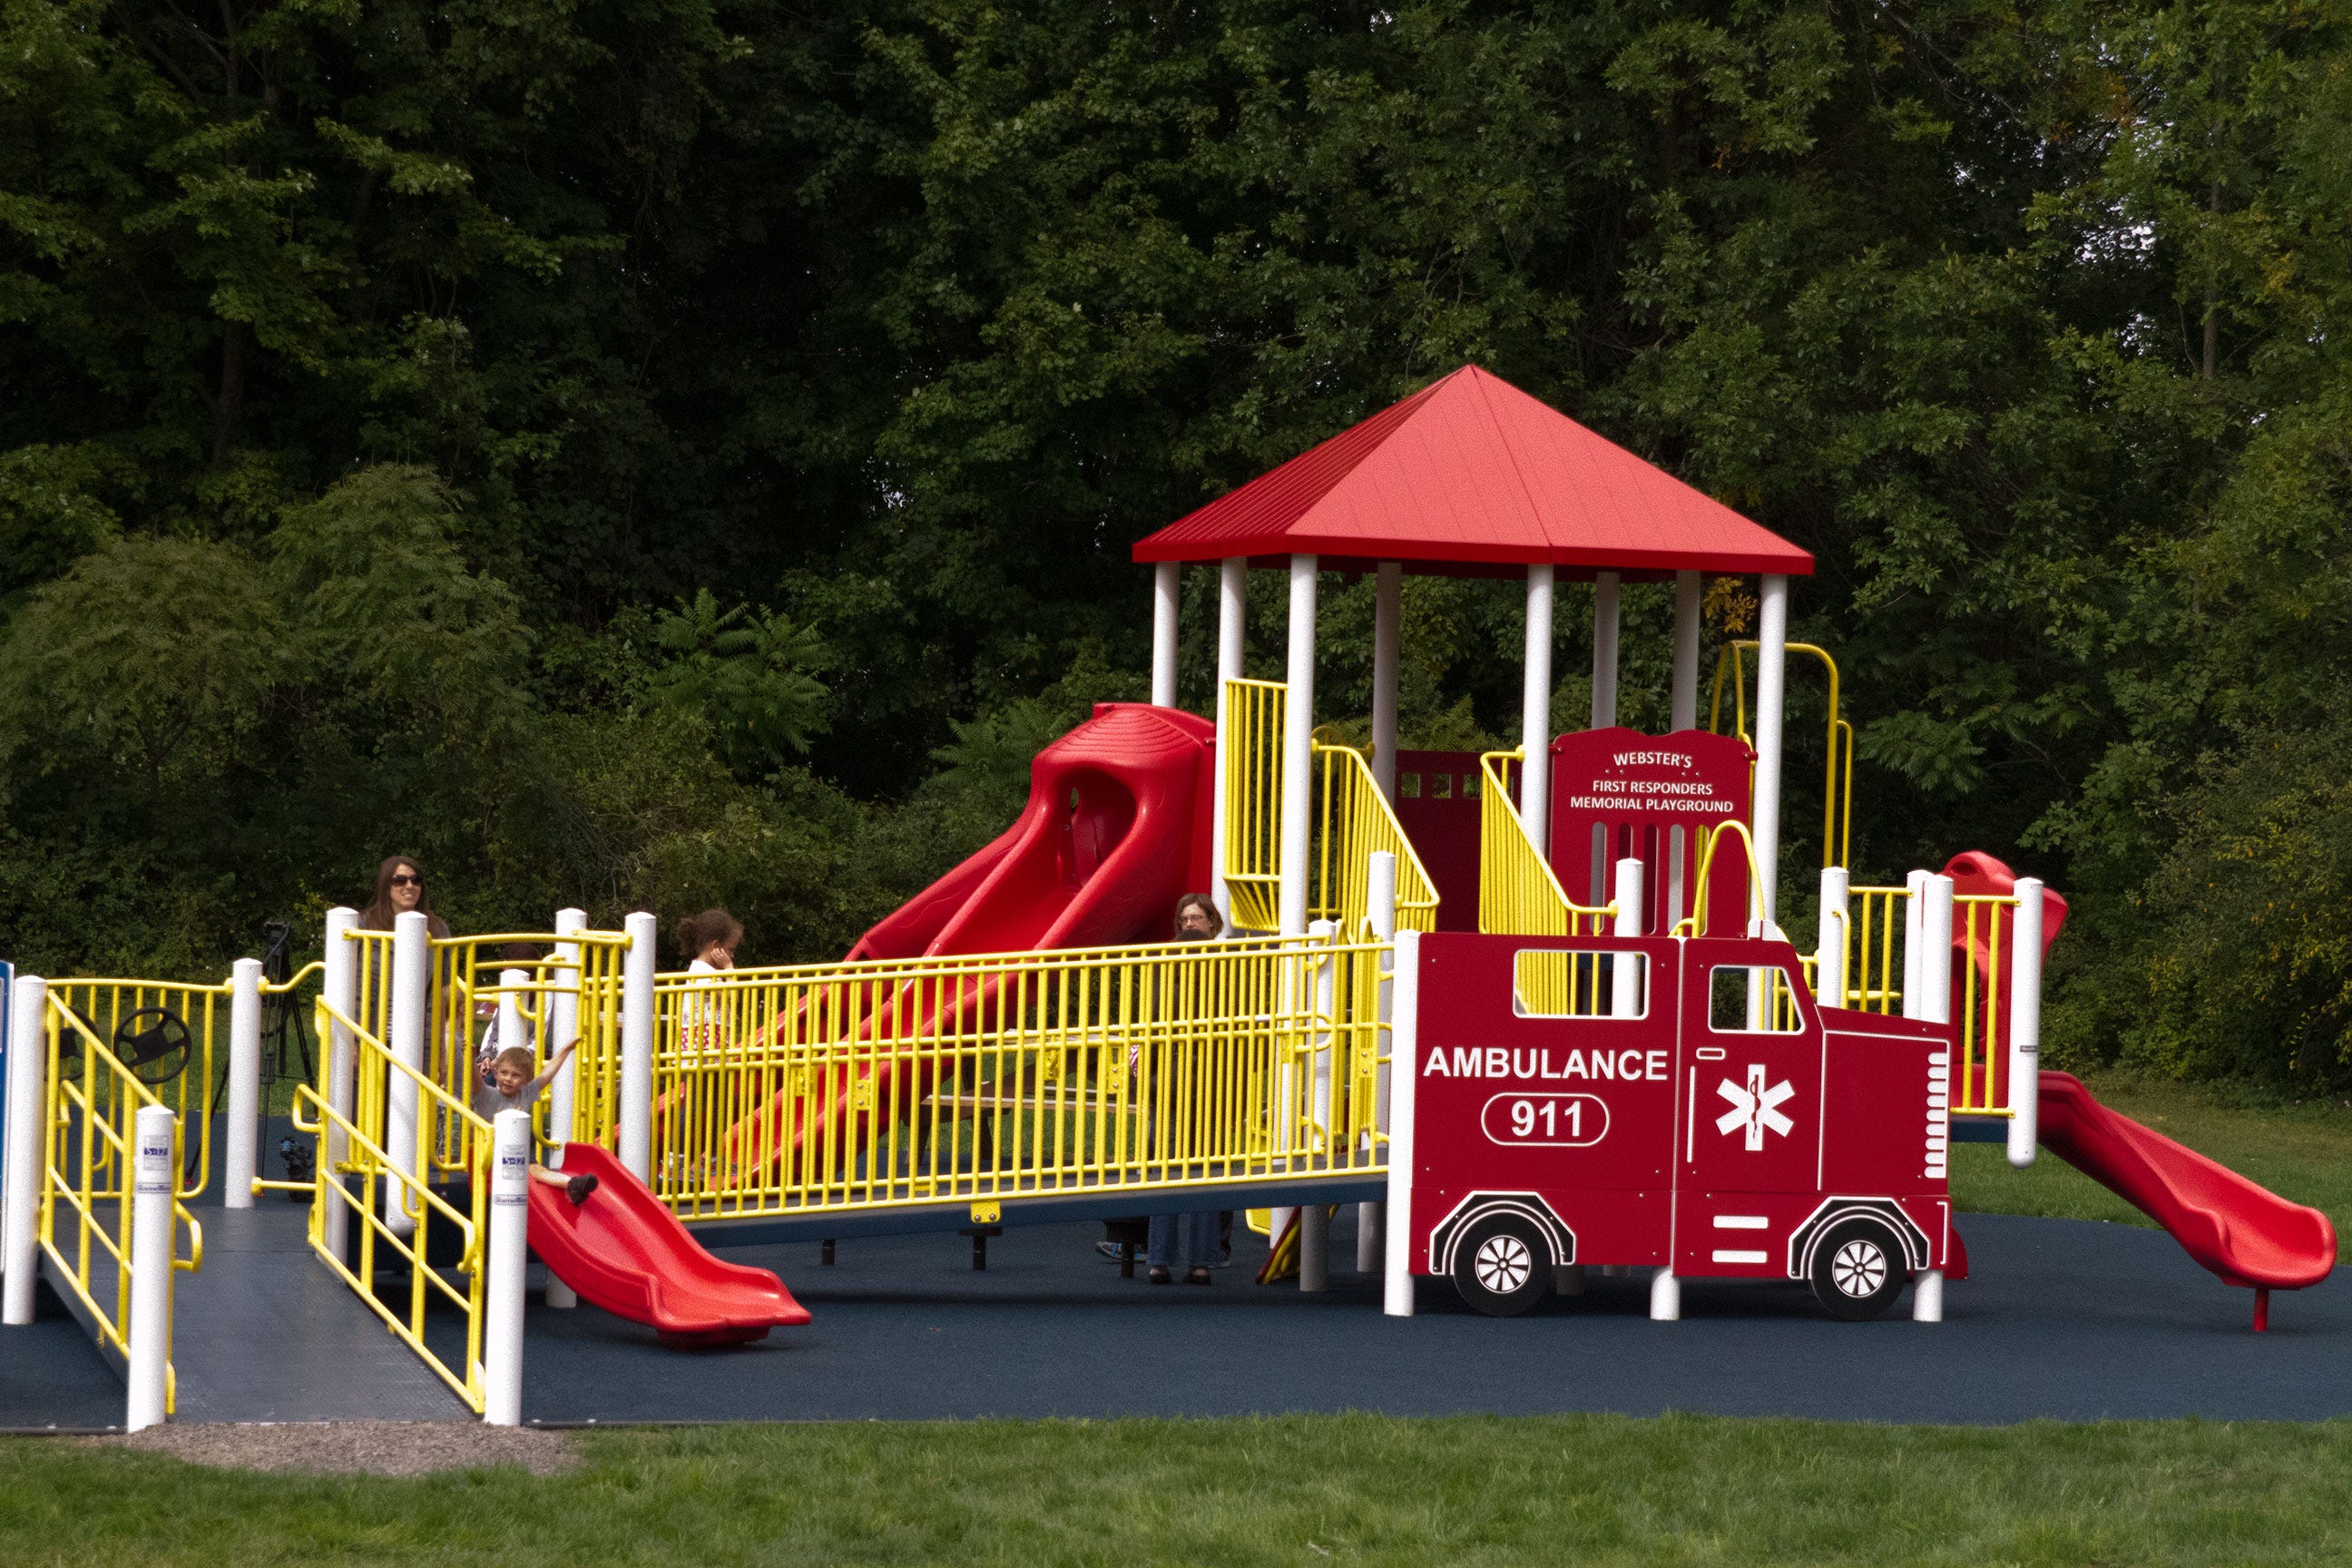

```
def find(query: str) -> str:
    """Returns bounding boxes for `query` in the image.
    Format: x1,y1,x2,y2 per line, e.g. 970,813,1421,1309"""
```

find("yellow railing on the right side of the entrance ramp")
294,996,489,1416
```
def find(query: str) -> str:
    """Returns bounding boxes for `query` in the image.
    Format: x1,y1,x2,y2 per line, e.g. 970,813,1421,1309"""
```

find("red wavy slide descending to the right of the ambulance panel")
2039,1072,2336,1328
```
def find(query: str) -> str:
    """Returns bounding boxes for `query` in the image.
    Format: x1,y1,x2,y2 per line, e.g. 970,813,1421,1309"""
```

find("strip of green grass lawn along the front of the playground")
0,1416,2352,1568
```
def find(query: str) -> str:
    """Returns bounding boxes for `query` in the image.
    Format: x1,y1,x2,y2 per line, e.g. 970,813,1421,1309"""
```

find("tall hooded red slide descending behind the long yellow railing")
730,703,1216,1161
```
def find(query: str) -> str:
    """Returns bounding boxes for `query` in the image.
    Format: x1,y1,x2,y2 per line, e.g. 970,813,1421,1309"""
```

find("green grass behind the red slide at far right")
1952,1077,2352,1234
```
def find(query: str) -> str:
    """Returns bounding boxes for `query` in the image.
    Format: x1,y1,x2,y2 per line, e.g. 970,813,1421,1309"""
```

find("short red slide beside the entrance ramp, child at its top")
532,1142,809,1347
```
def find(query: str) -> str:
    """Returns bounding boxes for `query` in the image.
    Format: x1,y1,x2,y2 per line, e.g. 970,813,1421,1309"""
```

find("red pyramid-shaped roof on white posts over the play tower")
1133,365,1813,576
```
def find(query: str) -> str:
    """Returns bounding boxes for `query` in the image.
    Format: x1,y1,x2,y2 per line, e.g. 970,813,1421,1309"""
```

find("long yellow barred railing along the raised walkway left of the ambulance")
634,938,1386,1220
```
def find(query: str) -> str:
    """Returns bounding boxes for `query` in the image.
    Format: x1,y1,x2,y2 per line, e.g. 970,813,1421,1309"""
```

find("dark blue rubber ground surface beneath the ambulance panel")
505,1210,2352,1425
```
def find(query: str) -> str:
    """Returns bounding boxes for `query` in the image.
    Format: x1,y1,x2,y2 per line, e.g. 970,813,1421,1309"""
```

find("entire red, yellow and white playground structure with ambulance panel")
5,369,2336,1420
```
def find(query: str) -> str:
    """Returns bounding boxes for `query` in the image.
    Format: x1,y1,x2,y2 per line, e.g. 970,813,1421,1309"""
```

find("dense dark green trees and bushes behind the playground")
0,0,2352,1082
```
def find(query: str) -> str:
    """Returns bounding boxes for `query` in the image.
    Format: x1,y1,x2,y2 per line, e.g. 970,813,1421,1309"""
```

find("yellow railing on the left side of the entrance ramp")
33,1001,210,1413
